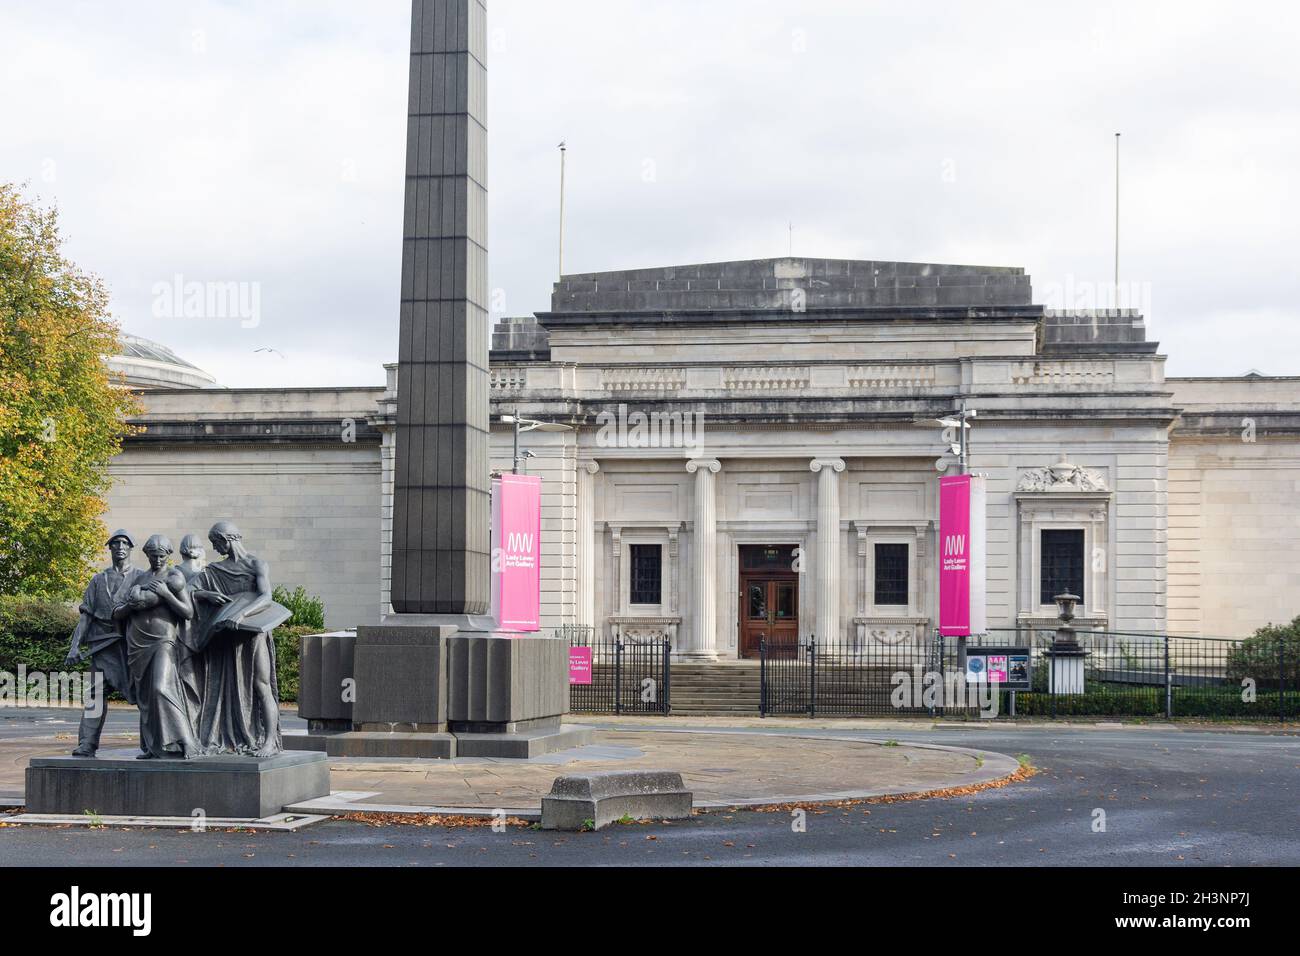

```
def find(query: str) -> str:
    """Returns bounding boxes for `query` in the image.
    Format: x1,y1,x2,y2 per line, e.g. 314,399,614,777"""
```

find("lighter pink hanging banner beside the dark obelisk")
491,475,542,631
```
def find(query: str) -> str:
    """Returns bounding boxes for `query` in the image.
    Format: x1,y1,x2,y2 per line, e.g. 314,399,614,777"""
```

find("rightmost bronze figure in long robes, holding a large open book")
186,522,290,757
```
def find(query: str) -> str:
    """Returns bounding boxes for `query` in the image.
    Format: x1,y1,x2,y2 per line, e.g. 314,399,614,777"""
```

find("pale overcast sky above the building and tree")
0,0,1300,386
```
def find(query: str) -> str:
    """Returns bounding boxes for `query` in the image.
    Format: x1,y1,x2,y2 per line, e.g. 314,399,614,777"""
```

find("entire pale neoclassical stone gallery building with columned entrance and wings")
105,259,1300,659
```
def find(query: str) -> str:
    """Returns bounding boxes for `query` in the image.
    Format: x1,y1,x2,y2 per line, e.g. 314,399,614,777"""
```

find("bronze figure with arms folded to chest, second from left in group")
113,535,199,760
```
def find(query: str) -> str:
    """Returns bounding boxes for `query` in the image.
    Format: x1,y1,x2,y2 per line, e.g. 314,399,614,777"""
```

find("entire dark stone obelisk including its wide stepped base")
291,0,590,757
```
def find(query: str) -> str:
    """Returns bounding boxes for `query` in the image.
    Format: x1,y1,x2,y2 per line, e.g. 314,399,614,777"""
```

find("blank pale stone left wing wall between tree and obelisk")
103,389,382,628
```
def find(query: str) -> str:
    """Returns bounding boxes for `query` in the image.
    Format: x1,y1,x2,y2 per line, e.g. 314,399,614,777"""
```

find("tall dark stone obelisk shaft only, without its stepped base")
391,0,491,615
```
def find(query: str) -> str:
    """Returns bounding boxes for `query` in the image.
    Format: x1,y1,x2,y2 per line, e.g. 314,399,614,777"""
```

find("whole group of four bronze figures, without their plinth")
68,522,290,760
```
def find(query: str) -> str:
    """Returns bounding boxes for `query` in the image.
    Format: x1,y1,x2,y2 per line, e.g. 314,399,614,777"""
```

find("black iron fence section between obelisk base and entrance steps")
555,624,672,714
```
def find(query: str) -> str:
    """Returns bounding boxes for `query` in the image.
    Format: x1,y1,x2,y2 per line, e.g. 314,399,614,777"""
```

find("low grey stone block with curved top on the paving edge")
542,770,692,830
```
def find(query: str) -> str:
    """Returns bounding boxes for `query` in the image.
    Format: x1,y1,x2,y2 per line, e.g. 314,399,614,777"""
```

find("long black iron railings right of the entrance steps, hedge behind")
759,628,1300,721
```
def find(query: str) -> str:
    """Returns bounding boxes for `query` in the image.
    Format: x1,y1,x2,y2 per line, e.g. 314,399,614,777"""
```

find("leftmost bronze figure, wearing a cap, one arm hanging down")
64,528,147,757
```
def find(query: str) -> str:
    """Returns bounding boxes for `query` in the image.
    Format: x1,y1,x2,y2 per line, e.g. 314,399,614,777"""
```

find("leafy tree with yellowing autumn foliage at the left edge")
0,183,139,597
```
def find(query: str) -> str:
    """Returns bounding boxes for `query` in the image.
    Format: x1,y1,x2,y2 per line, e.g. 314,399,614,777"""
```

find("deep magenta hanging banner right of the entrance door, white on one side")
939,475,988,637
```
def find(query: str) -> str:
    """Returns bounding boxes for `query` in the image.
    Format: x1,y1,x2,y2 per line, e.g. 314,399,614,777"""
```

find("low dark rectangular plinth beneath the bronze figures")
26,749,329,819
